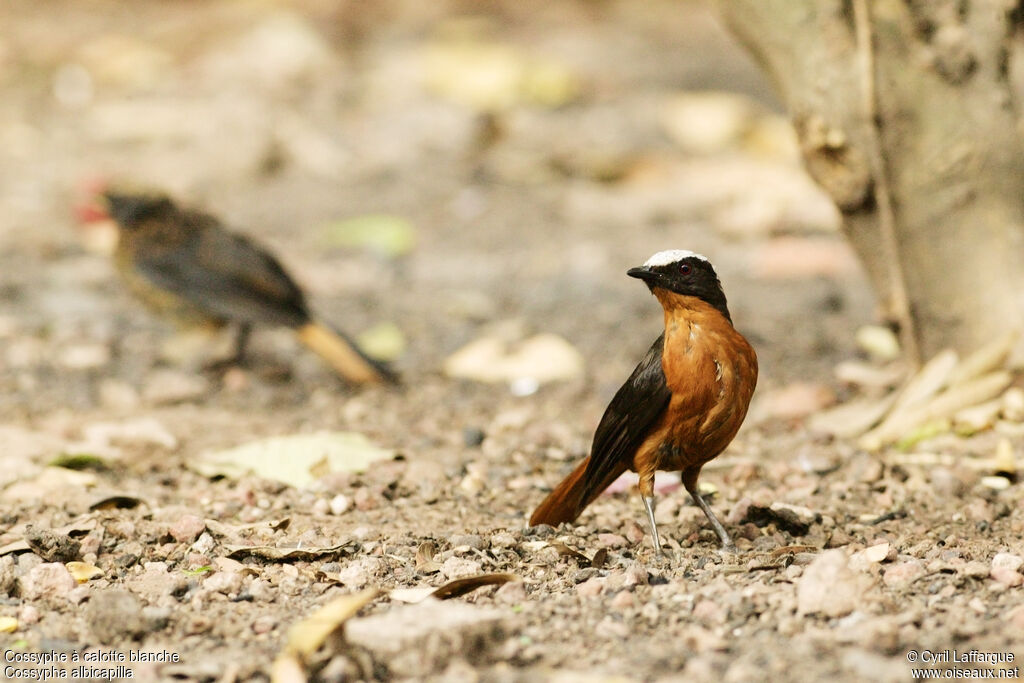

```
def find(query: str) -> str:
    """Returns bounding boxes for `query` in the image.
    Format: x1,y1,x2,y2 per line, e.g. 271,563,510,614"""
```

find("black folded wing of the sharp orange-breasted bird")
583,334,672,501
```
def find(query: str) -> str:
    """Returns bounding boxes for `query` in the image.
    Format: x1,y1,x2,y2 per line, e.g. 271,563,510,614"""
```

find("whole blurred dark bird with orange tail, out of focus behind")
78,186,397,384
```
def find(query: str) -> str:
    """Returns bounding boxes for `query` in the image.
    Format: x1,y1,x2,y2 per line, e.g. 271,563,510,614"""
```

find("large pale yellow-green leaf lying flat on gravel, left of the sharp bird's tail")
189,432,395,488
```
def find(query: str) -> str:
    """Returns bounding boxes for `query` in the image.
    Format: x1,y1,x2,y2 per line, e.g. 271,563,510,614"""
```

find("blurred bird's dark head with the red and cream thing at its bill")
75,180,174,253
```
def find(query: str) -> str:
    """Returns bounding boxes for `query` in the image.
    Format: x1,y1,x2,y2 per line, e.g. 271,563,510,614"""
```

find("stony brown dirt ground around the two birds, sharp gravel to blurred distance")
0,0,1024,681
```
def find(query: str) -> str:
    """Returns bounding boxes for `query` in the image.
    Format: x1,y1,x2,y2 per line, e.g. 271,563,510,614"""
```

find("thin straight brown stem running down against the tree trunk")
853,0,921,366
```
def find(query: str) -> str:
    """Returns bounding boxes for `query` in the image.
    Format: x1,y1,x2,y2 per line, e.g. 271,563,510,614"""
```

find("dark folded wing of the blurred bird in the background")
134,211,309,327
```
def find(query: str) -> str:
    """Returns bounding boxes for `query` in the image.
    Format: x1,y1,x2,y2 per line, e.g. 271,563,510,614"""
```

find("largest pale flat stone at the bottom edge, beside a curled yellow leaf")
345,599,509,679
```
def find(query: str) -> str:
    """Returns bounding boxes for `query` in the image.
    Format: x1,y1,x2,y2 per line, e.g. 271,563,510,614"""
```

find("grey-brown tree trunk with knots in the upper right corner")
717,0,1024,361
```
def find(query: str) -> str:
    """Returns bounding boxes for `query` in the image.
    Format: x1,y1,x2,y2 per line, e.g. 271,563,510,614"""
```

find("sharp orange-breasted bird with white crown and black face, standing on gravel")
529,249,758,554
